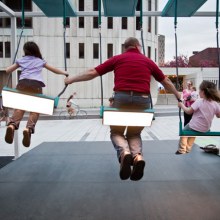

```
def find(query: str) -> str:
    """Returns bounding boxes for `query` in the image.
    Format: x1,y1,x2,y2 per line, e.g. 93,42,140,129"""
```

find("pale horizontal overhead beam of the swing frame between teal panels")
0,11,220,18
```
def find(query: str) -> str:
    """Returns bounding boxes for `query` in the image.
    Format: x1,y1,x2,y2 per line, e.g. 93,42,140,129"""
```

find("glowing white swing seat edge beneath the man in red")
103,111,154,126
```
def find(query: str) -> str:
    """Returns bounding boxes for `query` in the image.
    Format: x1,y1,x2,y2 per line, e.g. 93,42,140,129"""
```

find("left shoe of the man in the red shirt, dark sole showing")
119,152,132,180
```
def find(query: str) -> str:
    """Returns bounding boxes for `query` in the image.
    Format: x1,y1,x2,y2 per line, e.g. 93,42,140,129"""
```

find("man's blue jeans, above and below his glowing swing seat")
110,92,151,161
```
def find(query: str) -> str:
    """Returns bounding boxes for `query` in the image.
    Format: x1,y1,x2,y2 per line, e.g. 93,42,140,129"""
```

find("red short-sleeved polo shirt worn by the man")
95,48,165,94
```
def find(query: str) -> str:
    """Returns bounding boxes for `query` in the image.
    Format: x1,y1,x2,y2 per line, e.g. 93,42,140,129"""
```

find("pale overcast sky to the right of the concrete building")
158,0,217,62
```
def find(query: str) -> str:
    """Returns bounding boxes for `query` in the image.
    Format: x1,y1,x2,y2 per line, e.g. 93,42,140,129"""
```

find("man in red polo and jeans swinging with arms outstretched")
65,37,180,181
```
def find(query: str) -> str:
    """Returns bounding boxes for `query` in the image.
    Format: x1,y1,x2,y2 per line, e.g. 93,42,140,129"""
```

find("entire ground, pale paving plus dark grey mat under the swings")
0,106,220,220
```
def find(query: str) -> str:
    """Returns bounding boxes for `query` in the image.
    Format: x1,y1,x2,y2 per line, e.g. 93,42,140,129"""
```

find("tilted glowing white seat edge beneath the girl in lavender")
2,90,54,115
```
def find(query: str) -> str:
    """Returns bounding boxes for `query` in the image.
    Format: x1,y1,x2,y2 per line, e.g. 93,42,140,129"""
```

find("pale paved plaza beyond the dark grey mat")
0,106,220,156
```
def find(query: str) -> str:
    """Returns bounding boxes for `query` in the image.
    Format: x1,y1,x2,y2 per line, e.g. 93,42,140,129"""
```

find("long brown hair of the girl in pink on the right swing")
199,80,220,102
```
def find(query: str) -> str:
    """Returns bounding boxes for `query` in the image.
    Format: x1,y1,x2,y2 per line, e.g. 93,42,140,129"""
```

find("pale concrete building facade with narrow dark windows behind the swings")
0,0,158,107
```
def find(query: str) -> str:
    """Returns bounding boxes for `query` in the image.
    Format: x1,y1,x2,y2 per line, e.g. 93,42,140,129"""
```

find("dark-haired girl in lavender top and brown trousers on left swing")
5,41,68,147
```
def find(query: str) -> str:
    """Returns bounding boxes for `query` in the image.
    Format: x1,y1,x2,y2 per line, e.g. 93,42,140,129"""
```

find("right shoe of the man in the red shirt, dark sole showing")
130,154,145,181
